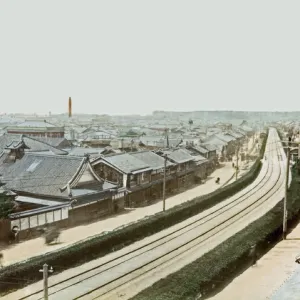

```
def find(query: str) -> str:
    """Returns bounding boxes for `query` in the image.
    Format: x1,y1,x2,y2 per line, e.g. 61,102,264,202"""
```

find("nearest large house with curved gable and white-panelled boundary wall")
0,152,124,238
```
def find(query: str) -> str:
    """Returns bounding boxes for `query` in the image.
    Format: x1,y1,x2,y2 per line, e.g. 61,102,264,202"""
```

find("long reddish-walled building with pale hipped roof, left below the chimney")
7,120,65,138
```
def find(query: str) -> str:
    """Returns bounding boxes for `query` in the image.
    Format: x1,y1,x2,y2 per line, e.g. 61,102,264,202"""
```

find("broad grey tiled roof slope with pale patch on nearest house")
0,153,83,196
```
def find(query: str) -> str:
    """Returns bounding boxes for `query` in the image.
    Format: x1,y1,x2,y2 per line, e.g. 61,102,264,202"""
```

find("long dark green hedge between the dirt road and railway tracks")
0,132,265,293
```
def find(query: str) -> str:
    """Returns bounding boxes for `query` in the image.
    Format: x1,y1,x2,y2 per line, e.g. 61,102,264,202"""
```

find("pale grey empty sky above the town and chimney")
0,0,300,115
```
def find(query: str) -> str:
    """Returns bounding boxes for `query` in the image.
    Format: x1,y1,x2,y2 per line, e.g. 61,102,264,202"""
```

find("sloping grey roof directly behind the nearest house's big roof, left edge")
0,133,67,155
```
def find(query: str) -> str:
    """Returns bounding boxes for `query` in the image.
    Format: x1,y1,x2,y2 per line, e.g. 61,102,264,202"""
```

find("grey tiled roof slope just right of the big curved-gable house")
102,153,150,174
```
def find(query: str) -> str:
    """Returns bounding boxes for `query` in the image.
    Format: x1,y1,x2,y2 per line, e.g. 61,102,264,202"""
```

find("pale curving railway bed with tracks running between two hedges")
5,129,285,300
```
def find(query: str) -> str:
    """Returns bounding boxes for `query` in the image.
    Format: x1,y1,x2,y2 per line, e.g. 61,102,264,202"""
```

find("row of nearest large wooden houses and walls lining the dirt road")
0,134,217,239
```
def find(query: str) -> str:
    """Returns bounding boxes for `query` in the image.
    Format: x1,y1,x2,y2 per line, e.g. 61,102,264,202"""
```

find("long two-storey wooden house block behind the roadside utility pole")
92,149,206,207
